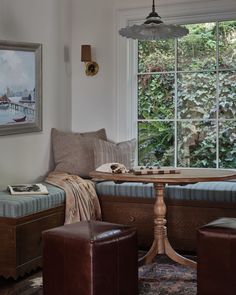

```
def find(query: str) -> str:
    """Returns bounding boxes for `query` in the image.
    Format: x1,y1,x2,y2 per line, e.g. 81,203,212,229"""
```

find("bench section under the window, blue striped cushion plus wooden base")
96,181,236,252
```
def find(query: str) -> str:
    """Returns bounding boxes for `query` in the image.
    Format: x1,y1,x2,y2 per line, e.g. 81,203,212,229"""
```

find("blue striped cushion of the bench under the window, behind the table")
96,181,236,203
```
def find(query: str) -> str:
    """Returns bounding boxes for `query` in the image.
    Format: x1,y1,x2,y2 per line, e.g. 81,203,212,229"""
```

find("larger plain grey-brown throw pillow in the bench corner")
51,128,107,178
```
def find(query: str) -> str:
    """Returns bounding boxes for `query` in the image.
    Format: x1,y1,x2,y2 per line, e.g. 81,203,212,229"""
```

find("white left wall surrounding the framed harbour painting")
0,0,71,186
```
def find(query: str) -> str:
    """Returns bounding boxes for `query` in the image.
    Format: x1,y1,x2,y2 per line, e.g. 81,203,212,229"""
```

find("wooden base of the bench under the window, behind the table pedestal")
99,195,236,252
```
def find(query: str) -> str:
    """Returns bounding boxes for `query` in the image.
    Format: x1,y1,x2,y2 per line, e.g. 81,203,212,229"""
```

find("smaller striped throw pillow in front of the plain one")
94,139,136,169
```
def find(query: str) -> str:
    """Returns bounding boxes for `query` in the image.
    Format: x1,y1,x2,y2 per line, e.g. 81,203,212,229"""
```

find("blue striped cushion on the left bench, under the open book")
0,184,65,218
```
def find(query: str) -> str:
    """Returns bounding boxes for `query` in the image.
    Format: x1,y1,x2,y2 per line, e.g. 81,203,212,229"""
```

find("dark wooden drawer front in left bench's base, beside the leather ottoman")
17,212,64,265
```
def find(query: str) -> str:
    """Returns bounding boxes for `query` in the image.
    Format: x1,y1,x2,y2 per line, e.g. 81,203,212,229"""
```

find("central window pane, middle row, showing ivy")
177,72,216,119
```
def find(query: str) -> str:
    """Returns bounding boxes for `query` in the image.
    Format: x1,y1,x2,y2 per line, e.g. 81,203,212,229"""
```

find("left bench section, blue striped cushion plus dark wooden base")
0,184,65,279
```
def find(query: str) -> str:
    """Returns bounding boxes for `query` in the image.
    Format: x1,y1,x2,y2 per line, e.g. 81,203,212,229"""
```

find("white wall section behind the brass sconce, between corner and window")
72,0,116,136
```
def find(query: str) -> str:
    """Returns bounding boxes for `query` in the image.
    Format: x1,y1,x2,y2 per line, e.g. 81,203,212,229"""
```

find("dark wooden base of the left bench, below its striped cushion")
0,205,64,279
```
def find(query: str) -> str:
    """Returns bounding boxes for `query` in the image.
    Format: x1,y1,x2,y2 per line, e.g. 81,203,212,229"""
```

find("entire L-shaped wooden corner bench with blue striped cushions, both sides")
0,181,236,278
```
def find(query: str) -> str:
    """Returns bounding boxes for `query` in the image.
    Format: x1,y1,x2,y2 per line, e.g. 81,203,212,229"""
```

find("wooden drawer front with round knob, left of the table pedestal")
101,201,153,248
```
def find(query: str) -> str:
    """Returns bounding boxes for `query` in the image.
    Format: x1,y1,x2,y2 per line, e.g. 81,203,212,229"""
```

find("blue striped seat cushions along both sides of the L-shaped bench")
0,181,236,218
